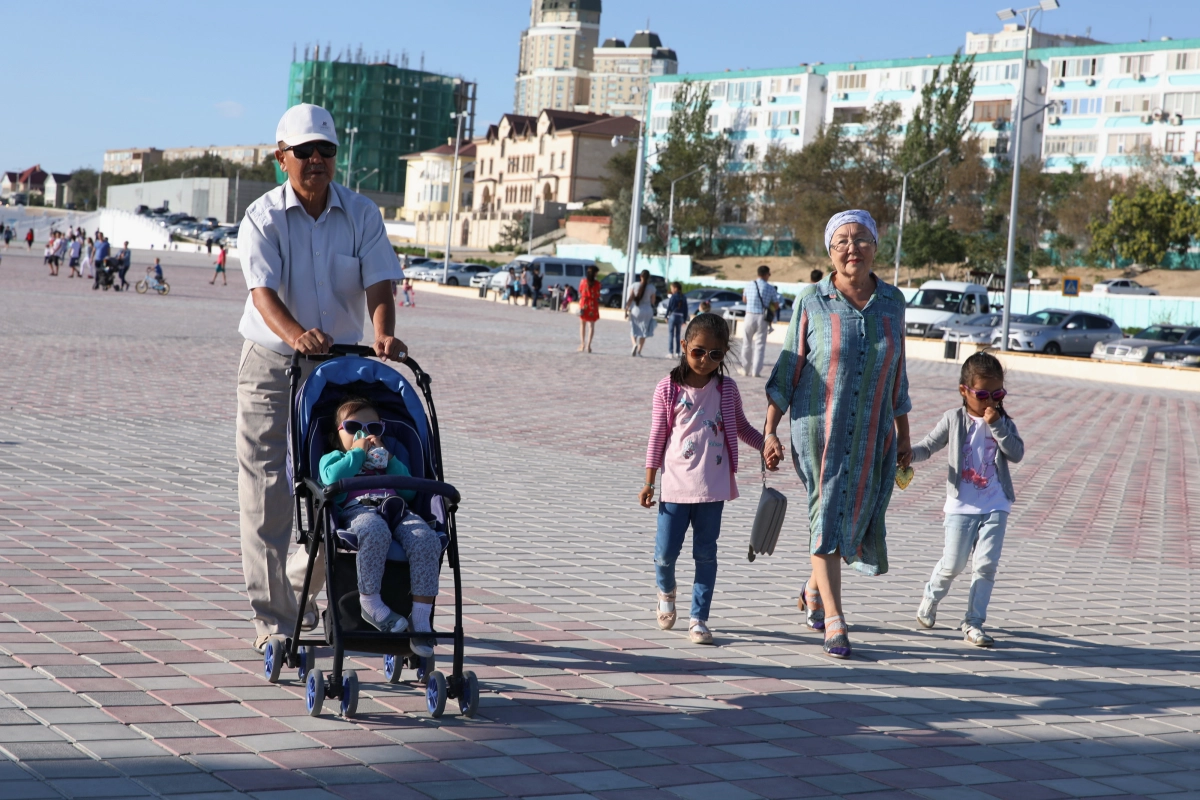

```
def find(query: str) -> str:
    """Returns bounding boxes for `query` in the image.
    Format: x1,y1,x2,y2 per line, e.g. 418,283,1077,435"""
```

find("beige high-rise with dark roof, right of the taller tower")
588,30,679,119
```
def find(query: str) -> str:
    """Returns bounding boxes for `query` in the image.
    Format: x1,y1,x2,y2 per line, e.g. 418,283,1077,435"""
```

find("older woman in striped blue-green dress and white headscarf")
764,210,912,658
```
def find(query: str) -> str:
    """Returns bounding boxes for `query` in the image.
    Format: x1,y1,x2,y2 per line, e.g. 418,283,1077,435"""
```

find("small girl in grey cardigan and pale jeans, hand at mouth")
912,353,1025,648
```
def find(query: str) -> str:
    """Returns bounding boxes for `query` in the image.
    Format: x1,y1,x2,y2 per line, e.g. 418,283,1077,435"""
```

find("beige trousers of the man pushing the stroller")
236,339,325,637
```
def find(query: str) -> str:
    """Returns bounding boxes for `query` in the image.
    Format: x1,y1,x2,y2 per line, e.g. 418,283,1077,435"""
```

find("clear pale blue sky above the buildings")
0,0,1200,172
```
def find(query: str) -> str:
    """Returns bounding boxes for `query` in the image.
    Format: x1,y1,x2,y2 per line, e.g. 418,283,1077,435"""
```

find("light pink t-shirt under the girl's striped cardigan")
660,377,738,503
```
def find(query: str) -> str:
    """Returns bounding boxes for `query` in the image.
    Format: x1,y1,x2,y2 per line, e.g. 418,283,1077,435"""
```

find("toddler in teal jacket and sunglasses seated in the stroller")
320,398,442,657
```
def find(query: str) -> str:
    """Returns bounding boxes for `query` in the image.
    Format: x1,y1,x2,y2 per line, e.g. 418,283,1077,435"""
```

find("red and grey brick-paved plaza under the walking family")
0,247,1200,800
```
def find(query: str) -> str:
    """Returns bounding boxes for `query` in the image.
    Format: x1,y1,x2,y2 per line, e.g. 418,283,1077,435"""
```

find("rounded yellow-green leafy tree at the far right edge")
1088,184,1200,266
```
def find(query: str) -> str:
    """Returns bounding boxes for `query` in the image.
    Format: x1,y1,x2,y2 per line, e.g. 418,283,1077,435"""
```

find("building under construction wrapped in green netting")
288,47,475,200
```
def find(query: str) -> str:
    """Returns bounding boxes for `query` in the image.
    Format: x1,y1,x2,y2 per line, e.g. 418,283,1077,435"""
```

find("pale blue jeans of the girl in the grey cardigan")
925,511,1008,627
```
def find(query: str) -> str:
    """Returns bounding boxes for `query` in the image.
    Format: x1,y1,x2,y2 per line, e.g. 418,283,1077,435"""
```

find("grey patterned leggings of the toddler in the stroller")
338,504,442,597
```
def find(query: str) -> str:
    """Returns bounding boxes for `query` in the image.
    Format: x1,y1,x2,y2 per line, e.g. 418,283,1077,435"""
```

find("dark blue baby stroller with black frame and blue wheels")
263,345,479,717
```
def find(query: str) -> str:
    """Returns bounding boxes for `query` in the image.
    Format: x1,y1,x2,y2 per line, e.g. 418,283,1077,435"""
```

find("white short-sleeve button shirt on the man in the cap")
238,182,404,355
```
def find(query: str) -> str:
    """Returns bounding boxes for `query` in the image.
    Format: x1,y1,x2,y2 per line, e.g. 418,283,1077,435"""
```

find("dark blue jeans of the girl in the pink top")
654,500,725,620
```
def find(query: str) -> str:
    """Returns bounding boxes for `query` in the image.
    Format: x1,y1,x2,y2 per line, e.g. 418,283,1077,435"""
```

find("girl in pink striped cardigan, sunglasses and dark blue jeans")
637,314,779,644
